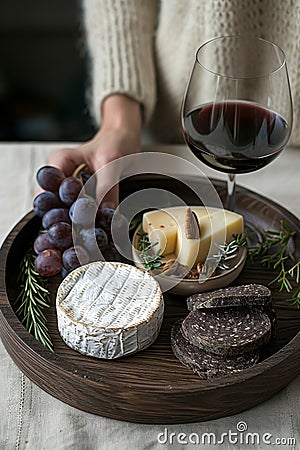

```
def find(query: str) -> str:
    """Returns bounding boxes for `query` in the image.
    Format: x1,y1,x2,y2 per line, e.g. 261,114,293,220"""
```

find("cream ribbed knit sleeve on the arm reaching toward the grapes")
83,0,157,123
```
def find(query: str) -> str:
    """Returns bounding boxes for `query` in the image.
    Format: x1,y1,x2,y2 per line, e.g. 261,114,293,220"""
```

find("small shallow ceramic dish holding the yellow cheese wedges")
132,225,247,296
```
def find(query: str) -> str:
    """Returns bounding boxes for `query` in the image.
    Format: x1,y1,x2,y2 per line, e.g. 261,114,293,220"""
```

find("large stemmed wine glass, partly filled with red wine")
181,35,293,210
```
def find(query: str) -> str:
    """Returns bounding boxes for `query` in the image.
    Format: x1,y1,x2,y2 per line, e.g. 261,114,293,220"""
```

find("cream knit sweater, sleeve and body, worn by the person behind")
84,0,300,145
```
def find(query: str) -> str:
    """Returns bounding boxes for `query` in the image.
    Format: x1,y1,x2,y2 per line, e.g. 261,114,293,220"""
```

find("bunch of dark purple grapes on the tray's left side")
33,166,120,277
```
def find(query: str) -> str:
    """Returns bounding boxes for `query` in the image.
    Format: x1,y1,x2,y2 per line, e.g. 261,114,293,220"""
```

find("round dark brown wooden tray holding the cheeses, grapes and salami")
0,176,300,424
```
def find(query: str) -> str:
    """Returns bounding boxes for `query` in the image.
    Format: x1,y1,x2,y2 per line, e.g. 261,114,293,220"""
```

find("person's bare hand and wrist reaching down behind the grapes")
49,95,141,207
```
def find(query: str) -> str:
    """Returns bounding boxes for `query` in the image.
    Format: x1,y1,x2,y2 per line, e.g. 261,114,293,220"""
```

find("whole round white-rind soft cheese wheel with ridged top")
56,261,164,359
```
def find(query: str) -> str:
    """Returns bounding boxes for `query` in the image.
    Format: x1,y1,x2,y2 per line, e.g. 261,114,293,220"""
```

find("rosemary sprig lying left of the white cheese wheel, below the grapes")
16,248,54,352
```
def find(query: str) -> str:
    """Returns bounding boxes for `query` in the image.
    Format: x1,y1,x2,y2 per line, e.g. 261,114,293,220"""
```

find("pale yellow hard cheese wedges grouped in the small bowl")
143,206,244,268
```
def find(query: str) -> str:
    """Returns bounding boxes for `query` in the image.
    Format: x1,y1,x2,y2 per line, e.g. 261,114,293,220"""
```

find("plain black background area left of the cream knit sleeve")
0,0,95,141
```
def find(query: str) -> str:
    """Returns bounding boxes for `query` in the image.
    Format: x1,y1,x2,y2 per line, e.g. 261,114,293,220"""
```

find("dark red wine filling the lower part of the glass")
183,101,290,173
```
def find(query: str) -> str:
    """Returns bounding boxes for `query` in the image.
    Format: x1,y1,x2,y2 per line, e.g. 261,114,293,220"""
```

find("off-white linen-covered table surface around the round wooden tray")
0,143,300,450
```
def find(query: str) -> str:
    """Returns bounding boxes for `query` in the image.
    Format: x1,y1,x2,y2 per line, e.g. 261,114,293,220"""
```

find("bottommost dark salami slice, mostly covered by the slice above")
171,321,259,379
